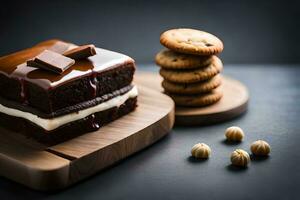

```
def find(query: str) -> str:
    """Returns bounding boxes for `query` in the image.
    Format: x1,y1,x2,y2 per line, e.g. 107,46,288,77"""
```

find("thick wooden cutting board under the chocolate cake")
0,86,174,191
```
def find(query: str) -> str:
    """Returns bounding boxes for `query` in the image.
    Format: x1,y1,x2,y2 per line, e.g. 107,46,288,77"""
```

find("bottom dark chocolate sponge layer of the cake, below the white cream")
0,97,137,145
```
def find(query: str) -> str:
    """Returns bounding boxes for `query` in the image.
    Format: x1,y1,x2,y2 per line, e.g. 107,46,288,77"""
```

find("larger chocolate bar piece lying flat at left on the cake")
27,50,75,74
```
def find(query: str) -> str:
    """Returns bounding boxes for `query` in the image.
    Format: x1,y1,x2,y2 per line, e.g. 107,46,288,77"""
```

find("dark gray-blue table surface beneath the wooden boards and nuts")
0,65,300,200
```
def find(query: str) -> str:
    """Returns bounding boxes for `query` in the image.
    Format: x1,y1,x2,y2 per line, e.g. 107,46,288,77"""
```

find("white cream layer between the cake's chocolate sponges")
0,86,138,131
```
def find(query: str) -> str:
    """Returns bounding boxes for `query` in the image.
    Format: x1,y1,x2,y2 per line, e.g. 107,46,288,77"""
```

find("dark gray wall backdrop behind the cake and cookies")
0,0,300,64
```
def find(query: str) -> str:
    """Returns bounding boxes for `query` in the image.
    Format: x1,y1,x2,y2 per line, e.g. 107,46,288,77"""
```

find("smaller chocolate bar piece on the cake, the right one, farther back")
63,44,96,60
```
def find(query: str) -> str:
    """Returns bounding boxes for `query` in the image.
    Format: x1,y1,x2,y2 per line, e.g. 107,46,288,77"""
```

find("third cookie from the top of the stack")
159,56,223,83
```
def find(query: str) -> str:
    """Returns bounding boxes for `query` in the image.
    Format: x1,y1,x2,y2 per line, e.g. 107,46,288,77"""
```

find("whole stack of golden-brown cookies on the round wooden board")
155,29,223,107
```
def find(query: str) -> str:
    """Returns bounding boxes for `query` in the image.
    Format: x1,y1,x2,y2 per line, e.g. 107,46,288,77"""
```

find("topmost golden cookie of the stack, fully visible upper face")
160,28,223,55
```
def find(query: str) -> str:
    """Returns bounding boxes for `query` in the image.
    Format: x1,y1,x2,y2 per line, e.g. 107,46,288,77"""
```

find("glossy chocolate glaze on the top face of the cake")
0,40,134,89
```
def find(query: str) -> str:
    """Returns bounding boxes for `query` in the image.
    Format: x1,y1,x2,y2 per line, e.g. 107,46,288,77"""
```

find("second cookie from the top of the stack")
155,49,212,69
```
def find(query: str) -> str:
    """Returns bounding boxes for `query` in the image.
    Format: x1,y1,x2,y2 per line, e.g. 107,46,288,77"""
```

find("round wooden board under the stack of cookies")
135,72,249,126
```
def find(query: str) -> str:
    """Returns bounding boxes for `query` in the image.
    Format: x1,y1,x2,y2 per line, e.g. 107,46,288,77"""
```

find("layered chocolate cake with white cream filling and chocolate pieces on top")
0,40,138,144
